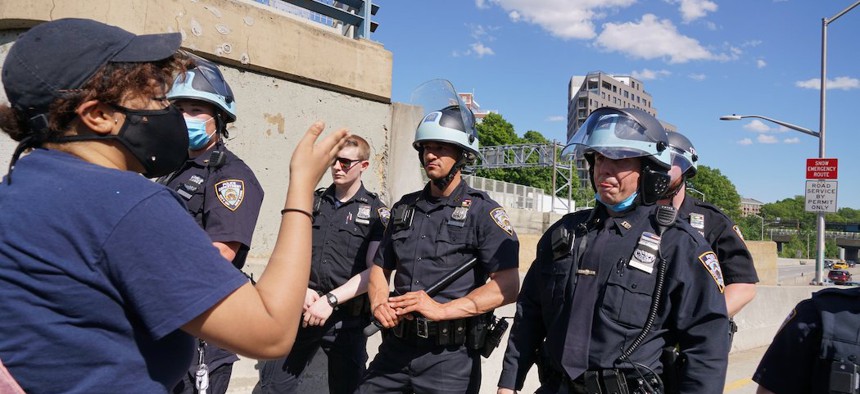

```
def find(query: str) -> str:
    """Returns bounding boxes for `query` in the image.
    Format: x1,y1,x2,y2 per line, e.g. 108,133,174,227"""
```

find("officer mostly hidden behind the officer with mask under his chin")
665,133,758,324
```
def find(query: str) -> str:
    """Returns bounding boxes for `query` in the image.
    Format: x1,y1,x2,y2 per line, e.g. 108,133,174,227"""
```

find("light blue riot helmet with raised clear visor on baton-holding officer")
411,79,481,189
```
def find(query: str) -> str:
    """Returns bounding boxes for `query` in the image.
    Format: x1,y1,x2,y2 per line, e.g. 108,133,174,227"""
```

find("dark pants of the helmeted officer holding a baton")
356,335,481,394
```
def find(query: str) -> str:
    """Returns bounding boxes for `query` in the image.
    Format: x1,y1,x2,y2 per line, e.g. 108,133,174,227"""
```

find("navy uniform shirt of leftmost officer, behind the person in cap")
158,142,263,267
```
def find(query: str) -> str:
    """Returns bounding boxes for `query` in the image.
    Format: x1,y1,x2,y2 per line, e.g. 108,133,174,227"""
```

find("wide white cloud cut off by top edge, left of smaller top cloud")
488,0,636,40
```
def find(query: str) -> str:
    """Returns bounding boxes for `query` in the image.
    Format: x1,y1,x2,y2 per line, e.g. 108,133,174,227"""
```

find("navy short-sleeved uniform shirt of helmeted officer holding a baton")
374,182,520,303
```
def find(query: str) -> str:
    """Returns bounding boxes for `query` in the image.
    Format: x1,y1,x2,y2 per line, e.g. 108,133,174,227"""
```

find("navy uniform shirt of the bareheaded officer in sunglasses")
308,184,389,293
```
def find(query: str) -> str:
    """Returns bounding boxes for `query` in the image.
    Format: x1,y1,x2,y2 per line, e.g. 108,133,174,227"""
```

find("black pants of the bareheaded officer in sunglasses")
254,315,367,394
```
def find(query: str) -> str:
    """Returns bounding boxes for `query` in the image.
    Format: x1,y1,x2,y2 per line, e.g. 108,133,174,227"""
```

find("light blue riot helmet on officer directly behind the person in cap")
167,54,236,137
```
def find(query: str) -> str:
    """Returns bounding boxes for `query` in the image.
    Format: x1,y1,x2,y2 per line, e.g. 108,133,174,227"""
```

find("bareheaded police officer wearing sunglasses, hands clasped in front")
254,135,389,394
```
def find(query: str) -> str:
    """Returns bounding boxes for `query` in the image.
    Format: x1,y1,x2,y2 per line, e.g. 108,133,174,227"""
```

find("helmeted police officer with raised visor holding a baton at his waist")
356,96,519,394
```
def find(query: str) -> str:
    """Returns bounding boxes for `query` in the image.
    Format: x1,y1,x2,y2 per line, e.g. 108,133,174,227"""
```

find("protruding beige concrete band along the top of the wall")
0,0,393,103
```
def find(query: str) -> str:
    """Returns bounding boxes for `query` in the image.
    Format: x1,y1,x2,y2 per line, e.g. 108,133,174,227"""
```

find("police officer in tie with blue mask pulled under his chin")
498,107,728,393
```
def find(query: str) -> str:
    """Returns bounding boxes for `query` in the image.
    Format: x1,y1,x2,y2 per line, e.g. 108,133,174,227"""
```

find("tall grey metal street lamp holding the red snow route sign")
720,0,860,284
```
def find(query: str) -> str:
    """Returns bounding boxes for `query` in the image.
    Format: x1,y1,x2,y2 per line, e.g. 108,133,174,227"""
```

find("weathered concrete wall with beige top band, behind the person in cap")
0,0,394,261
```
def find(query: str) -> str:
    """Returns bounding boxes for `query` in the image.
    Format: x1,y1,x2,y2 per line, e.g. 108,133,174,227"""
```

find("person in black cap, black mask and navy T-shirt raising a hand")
0,19,348,393
